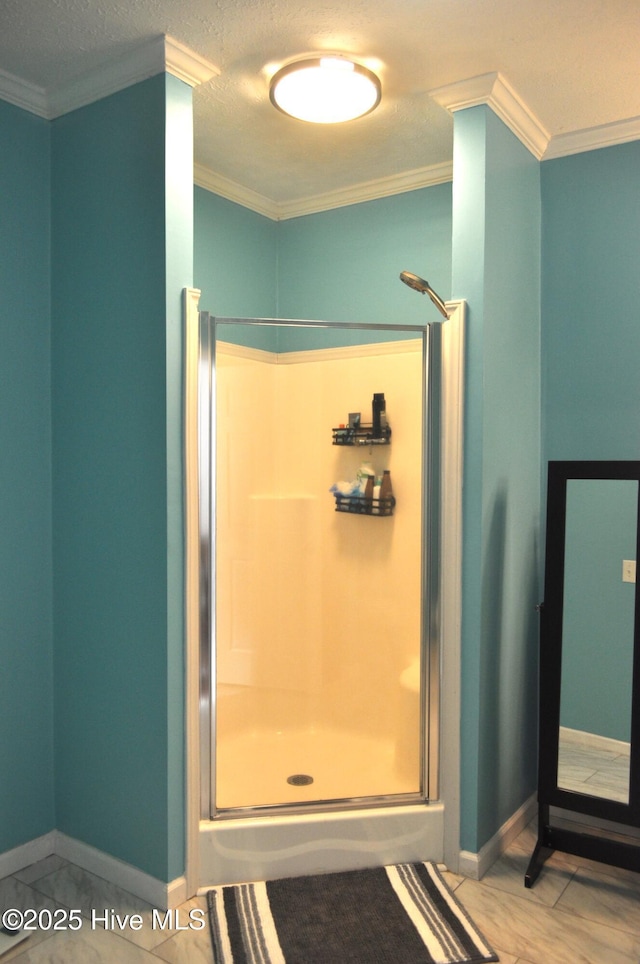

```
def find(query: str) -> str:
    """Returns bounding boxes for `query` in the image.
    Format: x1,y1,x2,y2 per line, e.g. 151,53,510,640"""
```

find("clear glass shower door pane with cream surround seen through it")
200,319,436,814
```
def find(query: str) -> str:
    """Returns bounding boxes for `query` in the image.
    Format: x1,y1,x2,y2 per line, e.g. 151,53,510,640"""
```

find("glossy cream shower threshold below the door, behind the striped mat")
198,802,444,892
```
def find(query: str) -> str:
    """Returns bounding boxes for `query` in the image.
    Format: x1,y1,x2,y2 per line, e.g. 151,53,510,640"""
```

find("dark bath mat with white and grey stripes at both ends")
207,863,498,964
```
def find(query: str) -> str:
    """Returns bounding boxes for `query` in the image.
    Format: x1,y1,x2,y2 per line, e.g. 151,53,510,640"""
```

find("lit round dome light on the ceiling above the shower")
269,57,381,124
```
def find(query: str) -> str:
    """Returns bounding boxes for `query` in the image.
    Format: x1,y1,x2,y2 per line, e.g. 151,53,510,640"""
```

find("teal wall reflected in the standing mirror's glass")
560,479,638,743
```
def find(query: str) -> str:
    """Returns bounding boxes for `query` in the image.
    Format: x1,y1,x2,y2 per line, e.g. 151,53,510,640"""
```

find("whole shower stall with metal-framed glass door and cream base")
182,294,468,884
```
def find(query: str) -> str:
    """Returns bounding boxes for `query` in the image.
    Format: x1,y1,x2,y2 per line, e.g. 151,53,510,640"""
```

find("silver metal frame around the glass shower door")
197,311,446,820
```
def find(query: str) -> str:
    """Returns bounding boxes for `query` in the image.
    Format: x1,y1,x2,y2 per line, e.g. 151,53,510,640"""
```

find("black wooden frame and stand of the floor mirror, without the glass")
525,461,640,887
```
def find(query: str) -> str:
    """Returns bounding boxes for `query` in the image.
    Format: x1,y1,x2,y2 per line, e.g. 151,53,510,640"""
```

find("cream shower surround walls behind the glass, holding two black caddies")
216,339,423,780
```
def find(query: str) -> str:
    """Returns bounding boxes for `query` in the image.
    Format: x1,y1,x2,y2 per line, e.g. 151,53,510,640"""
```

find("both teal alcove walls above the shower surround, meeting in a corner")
194,184,451,351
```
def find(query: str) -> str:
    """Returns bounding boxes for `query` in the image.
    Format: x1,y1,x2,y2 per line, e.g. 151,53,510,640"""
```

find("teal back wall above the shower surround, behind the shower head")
278,184,451,350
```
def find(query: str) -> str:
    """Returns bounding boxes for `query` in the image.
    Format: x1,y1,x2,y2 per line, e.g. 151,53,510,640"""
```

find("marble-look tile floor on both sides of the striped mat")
0,824,640,964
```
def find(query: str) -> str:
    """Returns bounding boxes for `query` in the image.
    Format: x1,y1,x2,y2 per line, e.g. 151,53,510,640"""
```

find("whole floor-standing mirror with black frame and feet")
525,461,640,887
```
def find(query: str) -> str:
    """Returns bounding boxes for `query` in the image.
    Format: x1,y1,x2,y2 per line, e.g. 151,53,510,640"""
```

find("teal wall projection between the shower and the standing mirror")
452,107,540,852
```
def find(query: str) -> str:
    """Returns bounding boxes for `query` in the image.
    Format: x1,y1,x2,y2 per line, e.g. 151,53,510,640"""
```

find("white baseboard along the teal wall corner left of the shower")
0,830,191,910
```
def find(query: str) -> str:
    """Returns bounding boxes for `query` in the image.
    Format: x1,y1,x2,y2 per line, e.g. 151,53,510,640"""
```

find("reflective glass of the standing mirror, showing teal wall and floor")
558,479,638,804
